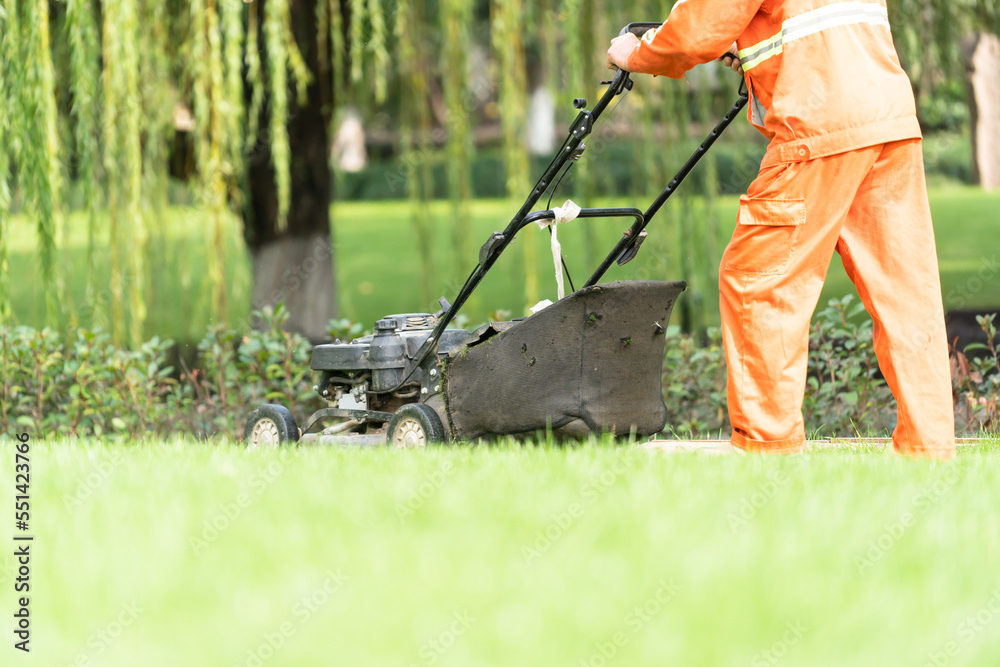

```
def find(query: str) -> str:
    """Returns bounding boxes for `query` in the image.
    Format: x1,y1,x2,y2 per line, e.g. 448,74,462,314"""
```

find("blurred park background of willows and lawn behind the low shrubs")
0,0,1000,346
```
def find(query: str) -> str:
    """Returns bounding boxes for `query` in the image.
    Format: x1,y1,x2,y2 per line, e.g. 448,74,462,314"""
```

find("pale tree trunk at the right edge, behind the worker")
962,33,1000,190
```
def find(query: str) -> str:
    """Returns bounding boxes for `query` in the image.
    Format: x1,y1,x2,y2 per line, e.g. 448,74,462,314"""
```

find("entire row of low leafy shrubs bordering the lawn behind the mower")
0,297,1000,438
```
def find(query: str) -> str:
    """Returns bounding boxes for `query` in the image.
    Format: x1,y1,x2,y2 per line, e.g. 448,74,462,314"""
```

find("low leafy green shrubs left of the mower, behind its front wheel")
0,306,318,437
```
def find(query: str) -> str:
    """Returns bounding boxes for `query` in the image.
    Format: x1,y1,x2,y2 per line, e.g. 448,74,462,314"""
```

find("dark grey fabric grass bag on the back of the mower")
444,281,686,440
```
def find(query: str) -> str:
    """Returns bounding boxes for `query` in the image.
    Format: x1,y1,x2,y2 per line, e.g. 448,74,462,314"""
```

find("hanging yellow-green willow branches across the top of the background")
0,0,1000,343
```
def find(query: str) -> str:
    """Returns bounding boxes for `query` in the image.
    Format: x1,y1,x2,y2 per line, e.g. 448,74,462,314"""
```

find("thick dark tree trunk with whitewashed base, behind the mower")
244,0,337,342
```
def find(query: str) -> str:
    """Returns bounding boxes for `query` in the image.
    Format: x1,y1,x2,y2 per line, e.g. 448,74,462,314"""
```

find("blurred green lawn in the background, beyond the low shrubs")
10,186,1000,340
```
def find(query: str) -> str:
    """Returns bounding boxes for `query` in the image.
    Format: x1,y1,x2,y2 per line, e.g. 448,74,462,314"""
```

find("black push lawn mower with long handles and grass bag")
244,23,748,448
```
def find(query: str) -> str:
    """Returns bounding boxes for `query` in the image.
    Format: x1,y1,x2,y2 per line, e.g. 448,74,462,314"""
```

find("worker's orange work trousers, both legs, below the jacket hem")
719,139,955,458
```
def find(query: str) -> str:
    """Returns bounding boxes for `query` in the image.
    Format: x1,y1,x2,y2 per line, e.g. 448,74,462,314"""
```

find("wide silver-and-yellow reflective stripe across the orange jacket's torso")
739,2,889,72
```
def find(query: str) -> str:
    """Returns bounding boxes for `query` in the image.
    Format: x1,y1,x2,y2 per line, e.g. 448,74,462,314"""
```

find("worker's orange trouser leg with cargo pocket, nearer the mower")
719,147,879,452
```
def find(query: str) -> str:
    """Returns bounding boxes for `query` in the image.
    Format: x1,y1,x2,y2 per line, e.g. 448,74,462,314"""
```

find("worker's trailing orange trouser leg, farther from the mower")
837,139,955,457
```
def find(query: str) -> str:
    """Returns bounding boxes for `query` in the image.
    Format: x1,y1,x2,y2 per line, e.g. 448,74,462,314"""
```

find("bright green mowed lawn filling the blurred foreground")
0,440,1000,667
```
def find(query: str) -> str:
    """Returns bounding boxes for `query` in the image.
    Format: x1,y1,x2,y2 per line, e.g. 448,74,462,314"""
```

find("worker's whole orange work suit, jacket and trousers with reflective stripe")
628,0,955,457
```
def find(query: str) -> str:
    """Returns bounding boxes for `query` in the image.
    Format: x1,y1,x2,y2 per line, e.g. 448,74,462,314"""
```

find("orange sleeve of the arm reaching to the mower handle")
628,0,763,79
